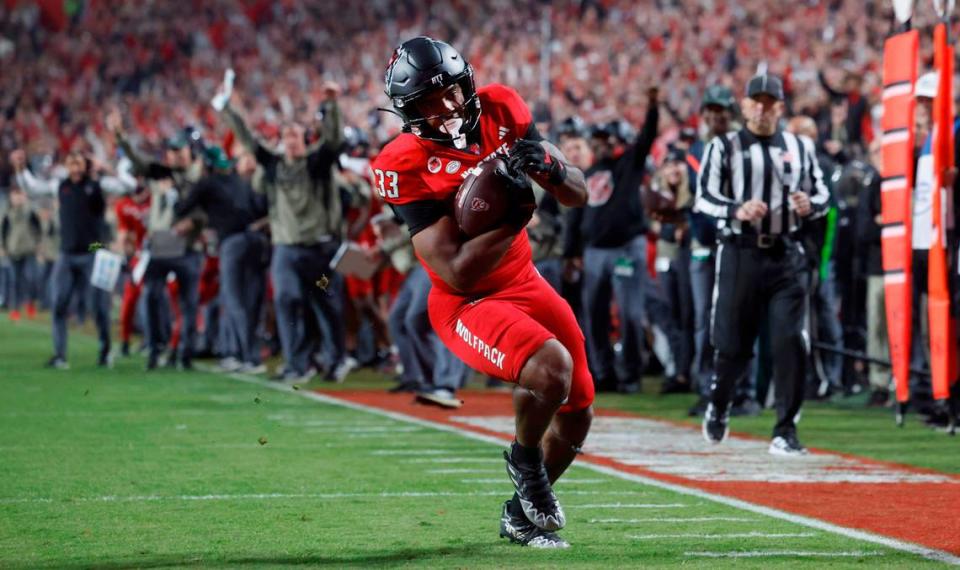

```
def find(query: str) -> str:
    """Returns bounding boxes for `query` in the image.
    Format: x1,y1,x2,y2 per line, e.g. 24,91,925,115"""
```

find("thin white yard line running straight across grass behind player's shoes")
0,491,644,506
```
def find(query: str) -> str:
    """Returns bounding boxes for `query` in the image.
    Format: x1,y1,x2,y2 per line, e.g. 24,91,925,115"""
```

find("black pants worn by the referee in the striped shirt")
710,240,808,436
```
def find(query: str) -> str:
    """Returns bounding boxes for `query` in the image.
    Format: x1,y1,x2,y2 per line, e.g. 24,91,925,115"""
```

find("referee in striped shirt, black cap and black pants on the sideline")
696,75,829,455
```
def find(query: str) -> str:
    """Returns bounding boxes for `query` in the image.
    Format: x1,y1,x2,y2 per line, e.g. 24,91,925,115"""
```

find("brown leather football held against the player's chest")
453,158,512,237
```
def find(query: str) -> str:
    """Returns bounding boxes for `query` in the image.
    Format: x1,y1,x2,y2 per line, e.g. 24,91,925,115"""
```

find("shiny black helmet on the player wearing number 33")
384,36,480,145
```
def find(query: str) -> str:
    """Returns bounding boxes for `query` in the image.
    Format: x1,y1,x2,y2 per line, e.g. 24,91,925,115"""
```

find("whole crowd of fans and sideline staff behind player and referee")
0,0,952,414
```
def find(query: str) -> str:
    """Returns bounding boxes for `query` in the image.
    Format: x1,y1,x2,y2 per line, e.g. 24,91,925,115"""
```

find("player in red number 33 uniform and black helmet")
371,37,594,548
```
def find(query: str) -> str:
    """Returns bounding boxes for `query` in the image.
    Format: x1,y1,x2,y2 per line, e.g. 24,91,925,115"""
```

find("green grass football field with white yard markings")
0,322,958,568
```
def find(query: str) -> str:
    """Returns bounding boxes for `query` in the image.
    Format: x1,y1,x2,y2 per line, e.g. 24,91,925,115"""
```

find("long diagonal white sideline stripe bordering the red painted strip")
214,368,960,566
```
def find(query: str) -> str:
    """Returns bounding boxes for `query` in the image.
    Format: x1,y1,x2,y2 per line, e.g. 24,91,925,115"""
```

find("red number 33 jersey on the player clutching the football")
370,84,533,294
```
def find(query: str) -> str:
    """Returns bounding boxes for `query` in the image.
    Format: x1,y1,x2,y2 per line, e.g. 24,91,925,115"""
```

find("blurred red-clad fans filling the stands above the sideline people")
0,0,952,163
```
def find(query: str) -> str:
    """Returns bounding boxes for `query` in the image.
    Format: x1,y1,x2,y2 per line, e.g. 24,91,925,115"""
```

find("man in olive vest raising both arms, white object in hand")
211,71,349,382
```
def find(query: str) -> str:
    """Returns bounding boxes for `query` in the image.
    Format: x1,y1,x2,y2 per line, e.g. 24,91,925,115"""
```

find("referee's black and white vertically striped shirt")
695,128,830,235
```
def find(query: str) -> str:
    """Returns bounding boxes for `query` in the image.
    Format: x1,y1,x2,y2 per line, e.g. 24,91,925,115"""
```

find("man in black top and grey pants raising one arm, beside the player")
564,88,660,391
